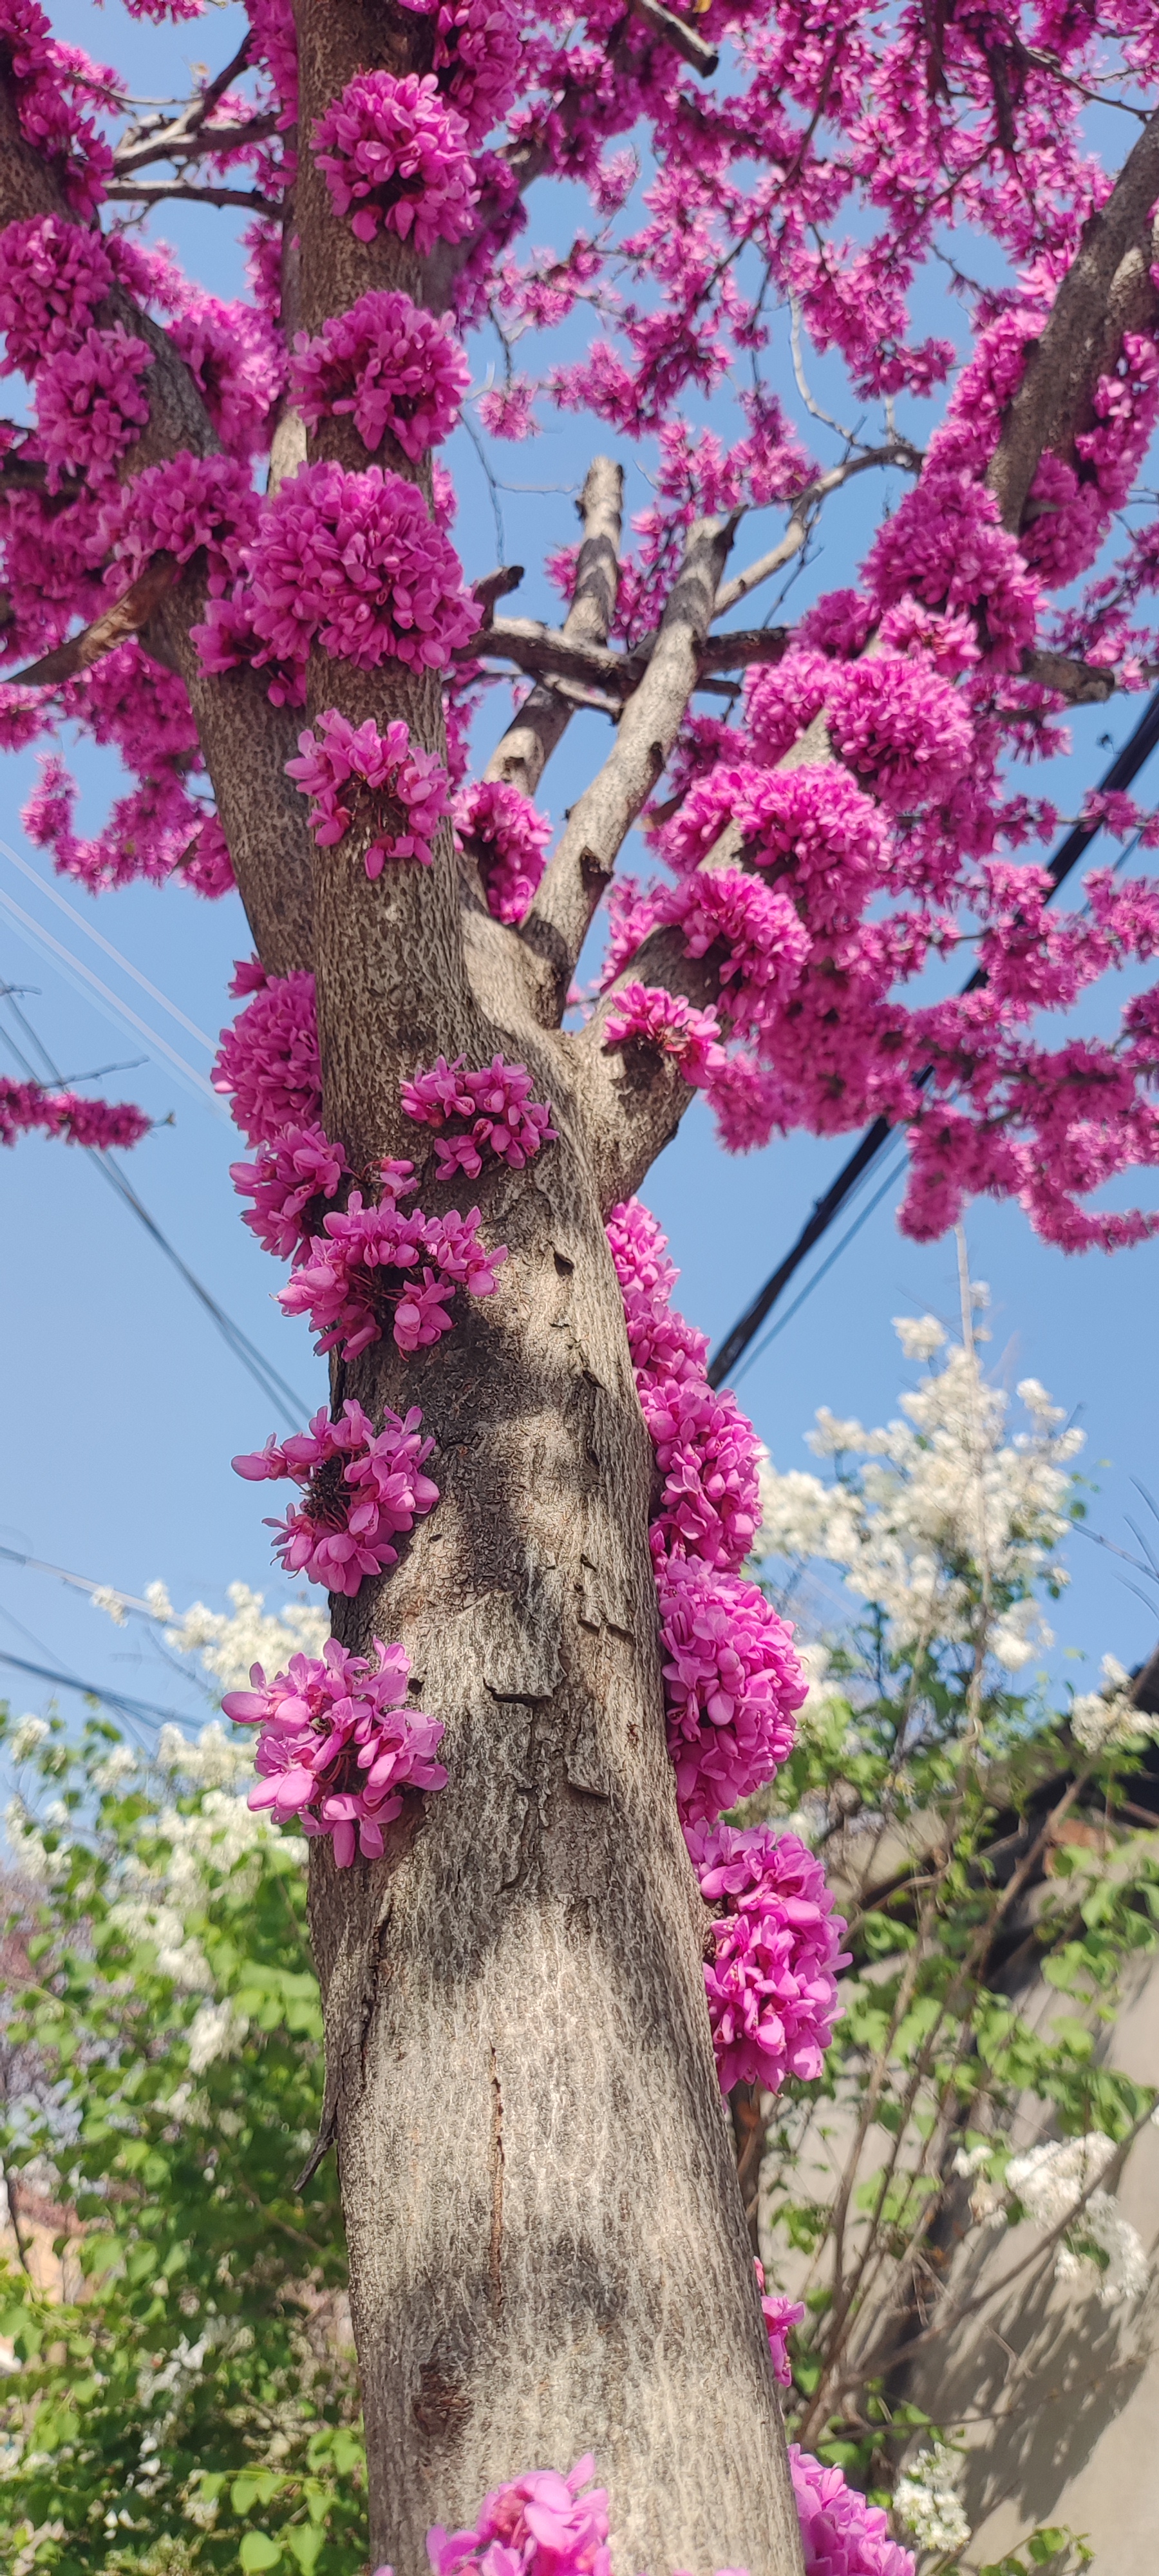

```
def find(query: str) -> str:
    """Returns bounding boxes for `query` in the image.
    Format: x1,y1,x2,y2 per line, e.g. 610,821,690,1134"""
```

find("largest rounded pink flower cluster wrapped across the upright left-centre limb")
250,464,482,670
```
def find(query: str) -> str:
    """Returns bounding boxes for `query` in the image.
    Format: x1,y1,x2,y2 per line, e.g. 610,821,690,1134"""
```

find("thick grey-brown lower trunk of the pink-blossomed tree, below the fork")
312,1100,798,2576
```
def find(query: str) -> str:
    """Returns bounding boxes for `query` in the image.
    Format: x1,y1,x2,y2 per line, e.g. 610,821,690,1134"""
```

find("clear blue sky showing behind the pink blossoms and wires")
0,0,1159,1752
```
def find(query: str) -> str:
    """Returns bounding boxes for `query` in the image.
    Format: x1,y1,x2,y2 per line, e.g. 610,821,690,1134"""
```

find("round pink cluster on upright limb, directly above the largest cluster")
292,291,471,464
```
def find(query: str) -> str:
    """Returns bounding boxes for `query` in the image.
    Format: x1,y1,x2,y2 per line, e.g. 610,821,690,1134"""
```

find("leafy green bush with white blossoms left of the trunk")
0,1721,366,2576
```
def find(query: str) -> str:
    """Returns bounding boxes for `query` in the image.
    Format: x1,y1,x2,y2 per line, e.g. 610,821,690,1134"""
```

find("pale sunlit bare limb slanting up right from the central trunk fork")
523,518,737,1028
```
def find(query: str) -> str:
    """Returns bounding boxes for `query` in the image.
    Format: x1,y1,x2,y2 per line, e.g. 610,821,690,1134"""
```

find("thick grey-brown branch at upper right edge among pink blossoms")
986,111,1159,536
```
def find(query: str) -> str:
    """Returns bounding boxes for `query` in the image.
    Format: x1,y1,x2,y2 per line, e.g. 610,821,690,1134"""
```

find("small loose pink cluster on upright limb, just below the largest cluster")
286,706,448,878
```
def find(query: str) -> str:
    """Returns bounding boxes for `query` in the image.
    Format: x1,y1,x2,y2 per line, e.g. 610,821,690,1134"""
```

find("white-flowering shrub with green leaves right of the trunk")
731,1262,1159,2571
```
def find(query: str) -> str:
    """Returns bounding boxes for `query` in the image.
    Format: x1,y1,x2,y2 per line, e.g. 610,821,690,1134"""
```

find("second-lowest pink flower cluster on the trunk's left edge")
234,1399,438,1600
